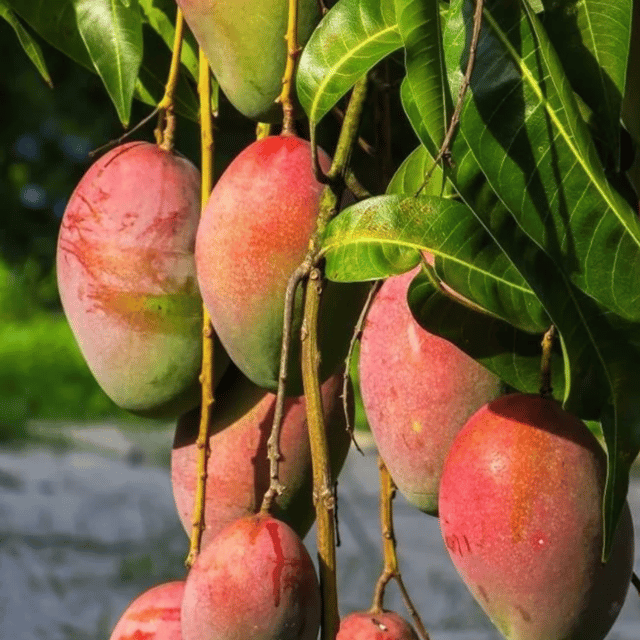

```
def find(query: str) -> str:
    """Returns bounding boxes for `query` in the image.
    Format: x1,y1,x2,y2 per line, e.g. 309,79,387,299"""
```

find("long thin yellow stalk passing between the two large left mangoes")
185,49,214,567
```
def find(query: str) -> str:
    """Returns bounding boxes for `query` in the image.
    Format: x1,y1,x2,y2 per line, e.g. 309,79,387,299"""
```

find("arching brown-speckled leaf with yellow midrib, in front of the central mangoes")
322,195,549,333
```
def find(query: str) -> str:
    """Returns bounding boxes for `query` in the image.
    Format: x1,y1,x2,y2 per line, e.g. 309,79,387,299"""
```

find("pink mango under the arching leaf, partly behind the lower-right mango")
360,269,502,515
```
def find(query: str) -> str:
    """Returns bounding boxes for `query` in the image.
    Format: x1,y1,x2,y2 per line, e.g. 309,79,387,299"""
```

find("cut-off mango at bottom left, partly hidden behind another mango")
109,580,185,640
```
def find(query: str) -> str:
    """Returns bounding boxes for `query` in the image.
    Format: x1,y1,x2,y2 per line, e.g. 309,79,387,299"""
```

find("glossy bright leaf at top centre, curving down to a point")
296,0,402,129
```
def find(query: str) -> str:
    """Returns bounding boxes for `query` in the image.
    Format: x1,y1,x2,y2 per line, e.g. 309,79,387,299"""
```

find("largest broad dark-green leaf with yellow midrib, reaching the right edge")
447,0,640,320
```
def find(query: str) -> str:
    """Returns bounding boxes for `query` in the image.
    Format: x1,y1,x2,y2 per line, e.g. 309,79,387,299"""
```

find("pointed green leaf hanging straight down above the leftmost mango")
73,0,142,126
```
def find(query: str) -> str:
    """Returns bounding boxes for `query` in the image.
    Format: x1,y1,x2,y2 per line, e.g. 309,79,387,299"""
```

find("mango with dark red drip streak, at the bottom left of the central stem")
182,514,320,640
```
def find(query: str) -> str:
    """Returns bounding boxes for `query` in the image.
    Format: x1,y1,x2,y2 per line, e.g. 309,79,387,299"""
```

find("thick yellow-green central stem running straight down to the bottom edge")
301,268,339,640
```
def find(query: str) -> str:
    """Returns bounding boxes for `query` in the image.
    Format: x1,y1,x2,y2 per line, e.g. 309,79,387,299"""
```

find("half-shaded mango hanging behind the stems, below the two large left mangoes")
171,375,350,546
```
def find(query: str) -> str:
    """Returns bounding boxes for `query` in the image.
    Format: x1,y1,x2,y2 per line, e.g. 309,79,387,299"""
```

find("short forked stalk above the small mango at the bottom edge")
369,456,429,640
